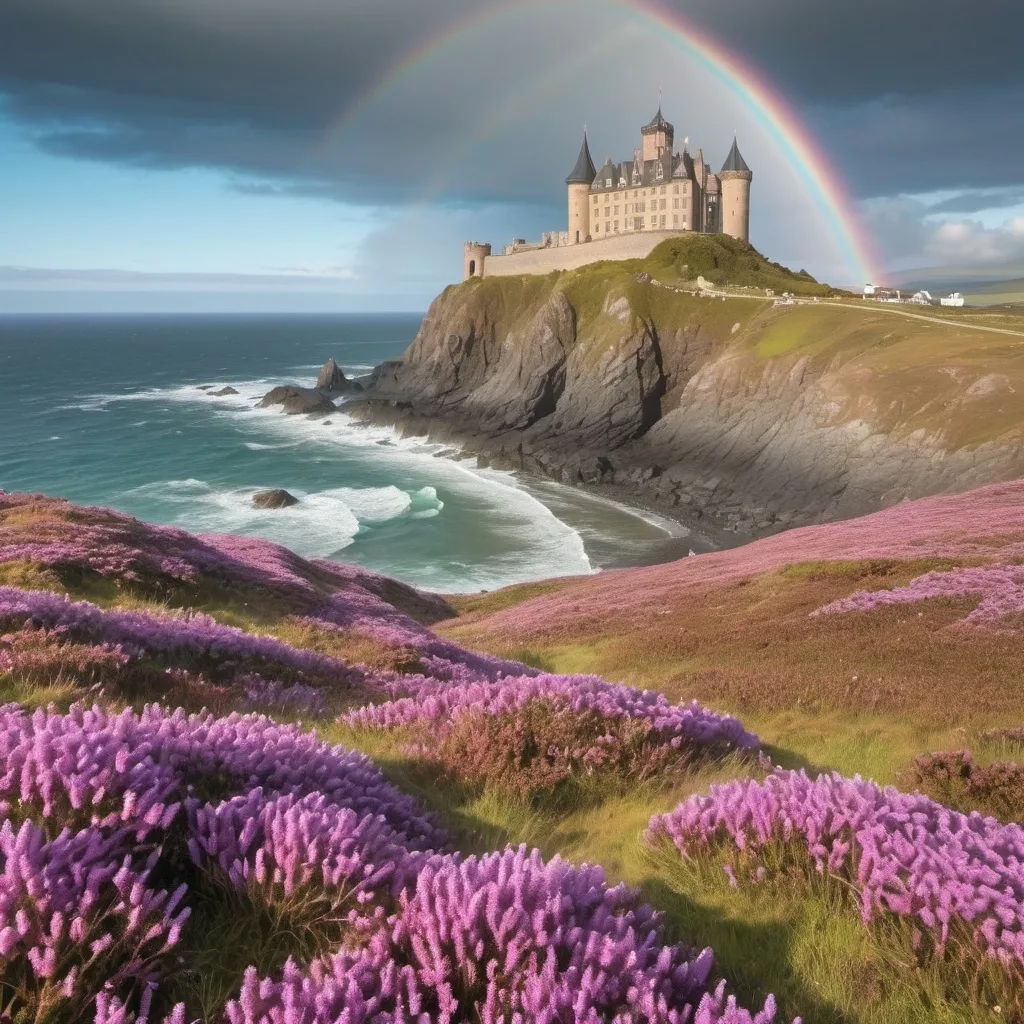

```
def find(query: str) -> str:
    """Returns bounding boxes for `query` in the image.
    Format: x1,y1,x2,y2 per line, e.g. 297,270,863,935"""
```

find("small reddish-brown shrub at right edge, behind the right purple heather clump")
902,751,1024,821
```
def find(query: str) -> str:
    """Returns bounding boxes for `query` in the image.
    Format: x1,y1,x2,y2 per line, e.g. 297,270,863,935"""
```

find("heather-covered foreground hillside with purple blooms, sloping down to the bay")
6,491,1024,1024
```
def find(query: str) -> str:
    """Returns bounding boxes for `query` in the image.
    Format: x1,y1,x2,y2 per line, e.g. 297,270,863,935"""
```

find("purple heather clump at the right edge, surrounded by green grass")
647,772,1024,971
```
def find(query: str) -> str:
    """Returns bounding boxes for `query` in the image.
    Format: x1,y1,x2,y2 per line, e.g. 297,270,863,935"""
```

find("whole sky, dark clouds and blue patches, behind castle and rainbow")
0,0,1024,311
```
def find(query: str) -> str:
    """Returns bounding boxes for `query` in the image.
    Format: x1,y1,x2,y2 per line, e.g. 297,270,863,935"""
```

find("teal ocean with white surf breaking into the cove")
0,314,686,593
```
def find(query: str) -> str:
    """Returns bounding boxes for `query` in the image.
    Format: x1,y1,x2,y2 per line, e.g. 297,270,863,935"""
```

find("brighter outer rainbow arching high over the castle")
325,0,882,281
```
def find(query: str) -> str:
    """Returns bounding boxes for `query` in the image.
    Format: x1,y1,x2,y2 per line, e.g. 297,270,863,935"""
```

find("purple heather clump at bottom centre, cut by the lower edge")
226,848,774,1024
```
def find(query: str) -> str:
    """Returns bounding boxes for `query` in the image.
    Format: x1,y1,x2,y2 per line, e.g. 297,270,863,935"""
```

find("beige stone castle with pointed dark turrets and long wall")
463,106,754,281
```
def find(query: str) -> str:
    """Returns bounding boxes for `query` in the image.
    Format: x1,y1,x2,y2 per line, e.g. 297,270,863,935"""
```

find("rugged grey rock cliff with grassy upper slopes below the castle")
359,241,1024,532
